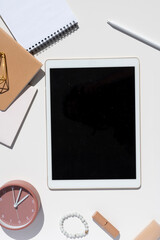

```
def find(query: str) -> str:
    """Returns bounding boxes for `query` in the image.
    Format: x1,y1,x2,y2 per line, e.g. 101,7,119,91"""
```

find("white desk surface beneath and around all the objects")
0,0,160,240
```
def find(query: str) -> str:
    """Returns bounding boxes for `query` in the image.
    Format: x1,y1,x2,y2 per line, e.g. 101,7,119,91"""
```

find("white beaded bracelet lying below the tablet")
60,213,89,238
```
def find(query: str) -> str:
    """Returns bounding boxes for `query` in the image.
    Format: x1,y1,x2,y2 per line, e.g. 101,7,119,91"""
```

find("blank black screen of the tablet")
50,67,136,180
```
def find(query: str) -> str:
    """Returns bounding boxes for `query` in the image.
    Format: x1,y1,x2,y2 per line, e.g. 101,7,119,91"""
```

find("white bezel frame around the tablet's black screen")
46,58,141,189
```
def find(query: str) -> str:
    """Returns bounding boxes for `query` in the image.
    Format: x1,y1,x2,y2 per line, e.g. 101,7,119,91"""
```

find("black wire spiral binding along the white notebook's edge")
26,21,79,54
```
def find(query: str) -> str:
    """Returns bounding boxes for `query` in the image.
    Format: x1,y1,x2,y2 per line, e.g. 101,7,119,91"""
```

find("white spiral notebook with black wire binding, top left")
0,0,78,53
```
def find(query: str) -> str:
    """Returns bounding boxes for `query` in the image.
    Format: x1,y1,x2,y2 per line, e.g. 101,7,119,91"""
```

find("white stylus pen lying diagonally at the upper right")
107,21,160,50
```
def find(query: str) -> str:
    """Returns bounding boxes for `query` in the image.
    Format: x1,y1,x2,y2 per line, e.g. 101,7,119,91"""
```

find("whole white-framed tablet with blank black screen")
46,58,140,189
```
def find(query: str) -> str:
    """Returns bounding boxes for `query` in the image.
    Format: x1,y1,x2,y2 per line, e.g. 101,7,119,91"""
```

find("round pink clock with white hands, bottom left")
0,180,40,230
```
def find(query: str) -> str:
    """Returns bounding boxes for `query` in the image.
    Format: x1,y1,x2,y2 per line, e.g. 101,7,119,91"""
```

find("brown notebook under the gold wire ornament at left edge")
0,28,42,111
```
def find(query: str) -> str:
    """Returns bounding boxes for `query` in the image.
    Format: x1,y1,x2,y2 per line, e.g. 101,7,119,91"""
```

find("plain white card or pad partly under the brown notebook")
0,86,37,147
